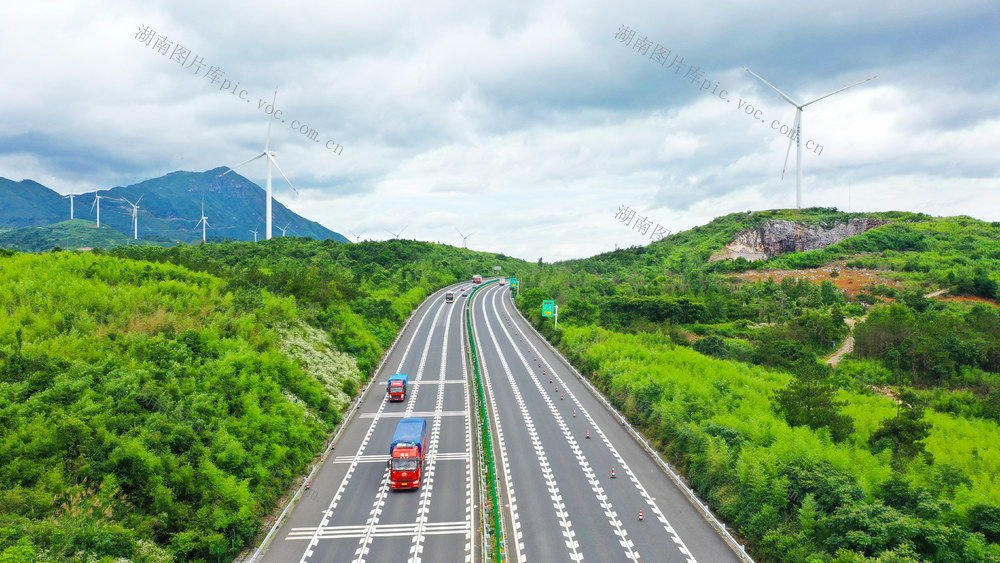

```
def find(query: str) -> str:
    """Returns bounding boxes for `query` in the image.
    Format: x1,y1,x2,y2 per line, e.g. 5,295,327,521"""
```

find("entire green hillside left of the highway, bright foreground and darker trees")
0,237,533,562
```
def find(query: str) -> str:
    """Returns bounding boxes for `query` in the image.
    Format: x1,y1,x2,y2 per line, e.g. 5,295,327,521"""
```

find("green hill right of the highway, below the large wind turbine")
518,209,1000,562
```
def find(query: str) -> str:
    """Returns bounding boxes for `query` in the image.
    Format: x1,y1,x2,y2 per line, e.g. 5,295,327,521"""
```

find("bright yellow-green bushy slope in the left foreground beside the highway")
0,252,342,561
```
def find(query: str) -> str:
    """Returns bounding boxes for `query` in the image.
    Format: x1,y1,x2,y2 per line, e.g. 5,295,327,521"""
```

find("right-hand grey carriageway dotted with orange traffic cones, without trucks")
473,286,741,563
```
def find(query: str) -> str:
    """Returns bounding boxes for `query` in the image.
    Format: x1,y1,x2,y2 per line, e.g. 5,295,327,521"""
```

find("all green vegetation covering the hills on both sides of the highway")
7,205,1000,562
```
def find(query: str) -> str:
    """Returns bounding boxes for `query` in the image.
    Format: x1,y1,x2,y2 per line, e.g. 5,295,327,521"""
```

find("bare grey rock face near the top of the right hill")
717,217,888,261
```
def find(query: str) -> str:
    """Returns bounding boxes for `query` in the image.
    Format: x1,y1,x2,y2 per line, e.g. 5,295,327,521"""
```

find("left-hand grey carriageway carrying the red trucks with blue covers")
257,284,479,563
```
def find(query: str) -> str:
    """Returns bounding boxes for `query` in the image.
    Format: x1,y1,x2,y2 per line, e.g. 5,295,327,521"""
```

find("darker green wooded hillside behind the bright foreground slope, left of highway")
112,237,526,373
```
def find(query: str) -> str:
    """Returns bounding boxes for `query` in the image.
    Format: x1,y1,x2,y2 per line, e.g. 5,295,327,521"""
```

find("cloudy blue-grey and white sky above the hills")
0,0,1000,261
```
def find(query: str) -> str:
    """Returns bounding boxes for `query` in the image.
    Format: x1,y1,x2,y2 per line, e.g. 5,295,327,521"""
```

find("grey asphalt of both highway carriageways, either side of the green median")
256,284,741,563
